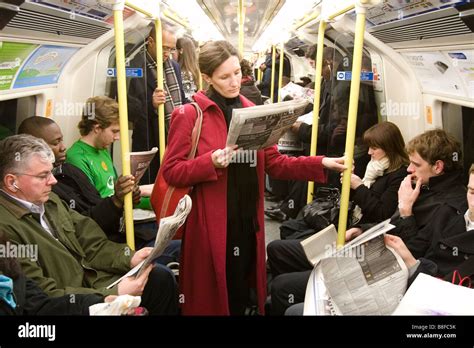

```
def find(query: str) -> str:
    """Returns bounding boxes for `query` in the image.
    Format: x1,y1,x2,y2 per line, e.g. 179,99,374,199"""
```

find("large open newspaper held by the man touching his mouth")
304,220,408,315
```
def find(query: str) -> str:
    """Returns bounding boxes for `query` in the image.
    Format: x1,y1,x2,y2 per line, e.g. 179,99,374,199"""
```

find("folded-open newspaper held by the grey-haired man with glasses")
107,195,192,289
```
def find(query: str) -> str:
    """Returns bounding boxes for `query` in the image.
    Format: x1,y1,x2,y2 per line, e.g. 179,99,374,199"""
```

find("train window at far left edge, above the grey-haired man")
0,96,36,139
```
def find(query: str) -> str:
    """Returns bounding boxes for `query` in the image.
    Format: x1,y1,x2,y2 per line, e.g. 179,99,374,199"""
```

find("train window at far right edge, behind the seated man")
442,103,474,182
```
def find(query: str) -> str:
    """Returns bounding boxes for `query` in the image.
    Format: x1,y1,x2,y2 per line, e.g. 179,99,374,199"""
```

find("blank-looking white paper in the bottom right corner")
393,273,474,315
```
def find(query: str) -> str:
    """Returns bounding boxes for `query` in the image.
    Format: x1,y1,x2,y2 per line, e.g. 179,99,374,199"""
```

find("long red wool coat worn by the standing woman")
162,92,326,315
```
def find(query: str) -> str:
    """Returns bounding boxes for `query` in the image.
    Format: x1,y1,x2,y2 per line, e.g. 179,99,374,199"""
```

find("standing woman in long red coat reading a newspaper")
163,41,345,315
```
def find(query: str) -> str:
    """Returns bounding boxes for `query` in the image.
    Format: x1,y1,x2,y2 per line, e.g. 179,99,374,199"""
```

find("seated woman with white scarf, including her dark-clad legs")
267,122,408,315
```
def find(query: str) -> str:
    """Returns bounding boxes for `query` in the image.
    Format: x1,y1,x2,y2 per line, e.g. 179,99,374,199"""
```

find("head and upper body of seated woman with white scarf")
351,122,408,223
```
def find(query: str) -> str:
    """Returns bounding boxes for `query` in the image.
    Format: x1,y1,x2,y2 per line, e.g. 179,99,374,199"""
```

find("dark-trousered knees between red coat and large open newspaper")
267,239,313,315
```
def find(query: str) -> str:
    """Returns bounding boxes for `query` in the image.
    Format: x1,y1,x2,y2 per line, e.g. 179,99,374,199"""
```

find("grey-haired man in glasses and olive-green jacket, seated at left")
0,134,177,314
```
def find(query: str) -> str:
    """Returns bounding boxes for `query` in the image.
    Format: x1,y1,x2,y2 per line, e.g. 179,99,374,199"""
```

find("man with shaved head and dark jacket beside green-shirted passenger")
18,116,181,265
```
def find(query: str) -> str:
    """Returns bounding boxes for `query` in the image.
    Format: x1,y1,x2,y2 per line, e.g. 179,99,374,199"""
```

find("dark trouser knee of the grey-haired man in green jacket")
141,264,178,315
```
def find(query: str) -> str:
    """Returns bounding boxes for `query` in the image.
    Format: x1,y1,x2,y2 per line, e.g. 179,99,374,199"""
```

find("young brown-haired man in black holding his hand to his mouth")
346,129,466,243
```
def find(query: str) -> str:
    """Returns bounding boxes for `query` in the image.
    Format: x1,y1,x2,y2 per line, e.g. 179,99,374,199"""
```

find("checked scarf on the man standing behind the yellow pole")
146,51,183,133
